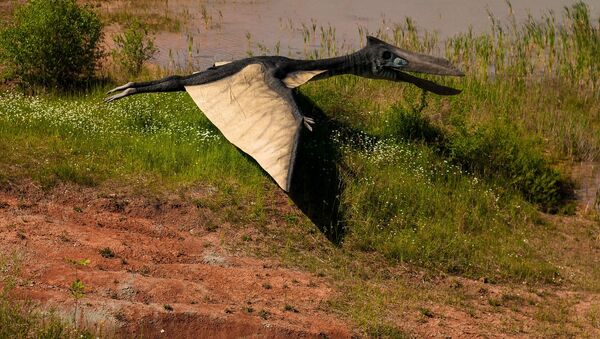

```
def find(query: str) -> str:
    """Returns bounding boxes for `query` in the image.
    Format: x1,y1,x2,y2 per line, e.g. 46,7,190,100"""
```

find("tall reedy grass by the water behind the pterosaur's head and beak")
282,2,600,161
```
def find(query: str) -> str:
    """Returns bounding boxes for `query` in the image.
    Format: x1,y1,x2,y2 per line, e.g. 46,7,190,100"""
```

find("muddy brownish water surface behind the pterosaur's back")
148,0,600,69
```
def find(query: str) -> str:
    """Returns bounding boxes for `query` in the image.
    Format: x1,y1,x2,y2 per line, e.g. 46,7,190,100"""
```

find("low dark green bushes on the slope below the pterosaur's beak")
386,107,574,213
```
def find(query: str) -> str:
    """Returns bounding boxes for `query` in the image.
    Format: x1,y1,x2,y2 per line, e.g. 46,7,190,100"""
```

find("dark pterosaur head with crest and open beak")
362,36,464,95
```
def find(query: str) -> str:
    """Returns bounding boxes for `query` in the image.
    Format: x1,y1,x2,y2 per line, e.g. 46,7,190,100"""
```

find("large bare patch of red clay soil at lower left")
0,184,352,338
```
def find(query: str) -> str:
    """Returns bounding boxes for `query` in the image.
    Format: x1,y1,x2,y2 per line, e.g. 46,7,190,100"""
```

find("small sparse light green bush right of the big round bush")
113,22,156,75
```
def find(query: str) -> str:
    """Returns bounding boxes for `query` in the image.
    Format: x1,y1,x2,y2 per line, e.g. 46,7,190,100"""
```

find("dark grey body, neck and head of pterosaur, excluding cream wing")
105,36,464,107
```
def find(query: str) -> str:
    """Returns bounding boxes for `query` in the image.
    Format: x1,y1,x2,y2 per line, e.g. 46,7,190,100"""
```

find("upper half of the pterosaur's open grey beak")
394,47,465,76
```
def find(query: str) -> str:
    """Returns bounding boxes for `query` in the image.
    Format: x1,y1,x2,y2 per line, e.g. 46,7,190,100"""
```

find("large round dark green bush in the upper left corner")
0,0,102,89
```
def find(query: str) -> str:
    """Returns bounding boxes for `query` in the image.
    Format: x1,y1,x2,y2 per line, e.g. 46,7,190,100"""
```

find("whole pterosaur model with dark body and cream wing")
106,36,463,192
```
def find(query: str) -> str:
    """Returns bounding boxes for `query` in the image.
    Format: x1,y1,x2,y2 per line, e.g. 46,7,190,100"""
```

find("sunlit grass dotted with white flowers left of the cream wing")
0,92,266,197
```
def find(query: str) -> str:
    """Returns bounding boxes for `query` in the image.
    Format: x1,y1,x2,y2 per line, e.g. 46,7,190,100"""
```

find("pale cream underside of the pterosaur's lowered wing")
185,64,302,191
